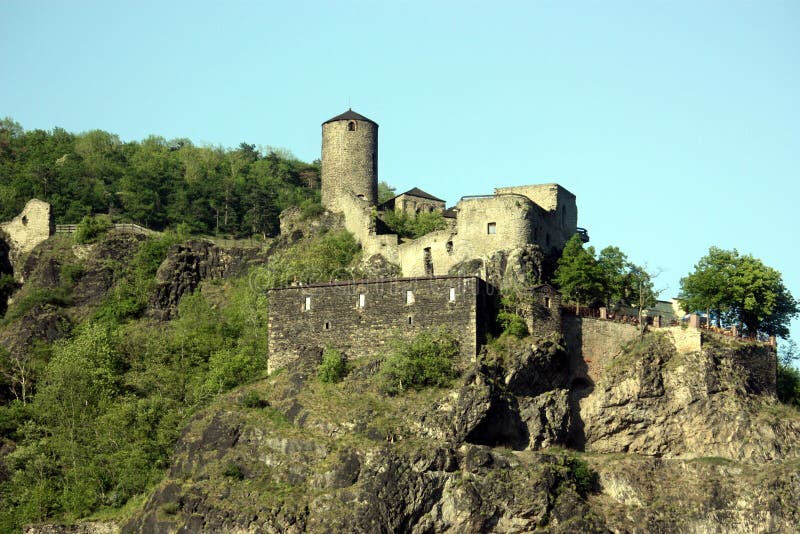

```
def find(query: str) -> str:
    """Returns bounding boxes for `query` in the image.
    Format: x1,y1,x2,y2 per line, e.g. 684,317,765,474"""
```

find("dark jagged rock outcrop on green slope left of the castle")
149,240,266,320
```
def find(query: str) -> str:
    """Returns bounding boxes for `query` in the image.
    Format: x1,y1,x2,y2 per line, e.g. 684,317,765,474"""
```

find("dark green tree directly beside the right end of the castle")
553,234,605,312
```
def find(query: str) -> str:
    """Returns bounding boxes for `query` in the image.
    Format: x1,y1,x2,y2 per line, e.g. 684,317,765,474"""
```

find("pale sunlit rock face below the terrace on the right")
575,340,800,462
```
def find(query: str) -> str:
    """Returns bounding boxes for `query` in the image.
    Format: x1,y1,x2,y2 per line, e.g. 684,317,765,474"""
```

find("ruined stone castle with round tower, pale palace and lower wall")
269,109,588,372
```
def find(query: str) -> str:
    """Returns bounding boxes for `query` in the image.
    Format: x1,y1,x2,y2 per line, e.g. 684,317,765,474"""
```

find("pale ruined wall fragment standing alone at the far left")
0,198,55,281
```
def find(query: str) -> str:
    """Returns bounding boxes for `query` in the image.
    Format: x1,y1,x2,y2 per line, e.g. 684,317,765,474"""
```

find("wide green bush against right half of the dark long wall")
381,329,459,393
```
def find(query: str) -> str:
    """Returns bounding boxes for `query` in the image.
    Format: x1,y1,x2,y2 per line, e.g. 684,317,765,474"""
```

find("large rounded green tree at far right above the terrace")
679,247,800,337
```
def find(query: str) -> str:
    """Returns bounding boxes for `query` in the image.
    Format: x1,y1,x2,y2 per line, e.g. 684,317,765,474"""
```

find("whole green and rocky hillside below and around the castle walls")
0,210,800,532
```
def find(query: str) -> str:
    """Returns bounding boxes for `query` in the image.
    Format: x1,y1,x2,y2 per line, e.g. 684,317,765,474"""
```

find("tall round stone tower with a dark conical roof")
322,109,378,211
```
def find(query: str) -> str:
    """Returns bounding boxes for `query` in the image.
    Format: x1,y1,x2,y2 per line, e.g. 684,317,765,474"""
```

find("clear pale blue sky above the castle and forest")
0,0,800,344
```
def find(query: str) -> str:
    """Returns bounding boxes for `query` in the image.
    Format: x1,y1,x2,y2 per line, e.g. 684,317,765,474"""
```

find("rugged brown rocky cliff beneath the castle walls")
123,337,800,532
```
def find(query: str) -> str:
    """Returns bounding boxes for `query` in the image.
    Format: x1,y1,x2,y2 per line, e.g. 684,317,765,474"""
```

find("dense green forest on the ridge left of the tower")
0,118,319,237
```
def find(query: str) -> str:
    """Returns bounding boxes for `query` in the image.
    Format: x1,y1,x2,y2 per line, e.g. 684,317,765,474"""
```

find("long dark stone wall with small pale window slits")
268,276,493,372
